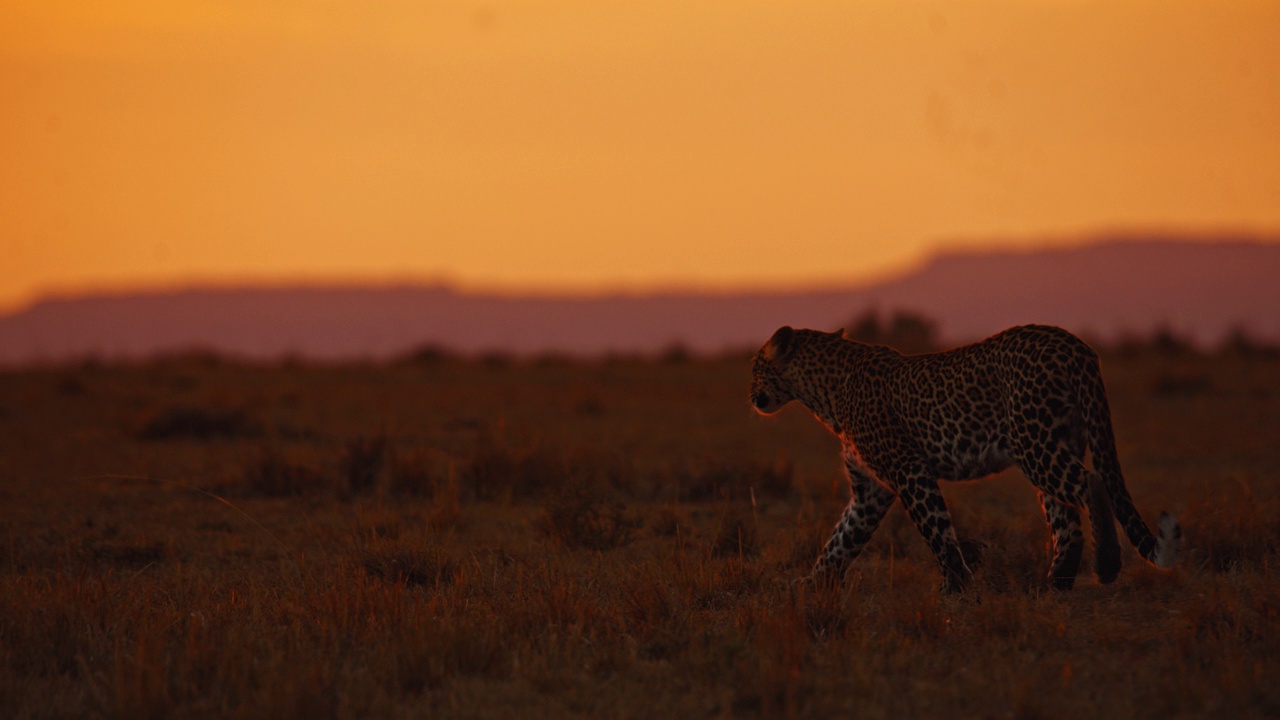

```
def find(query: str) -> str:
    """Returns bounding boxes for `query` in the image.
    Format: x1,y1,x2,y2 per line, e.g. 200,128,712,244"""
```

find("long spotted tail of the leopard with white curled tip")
1080,359,1183,568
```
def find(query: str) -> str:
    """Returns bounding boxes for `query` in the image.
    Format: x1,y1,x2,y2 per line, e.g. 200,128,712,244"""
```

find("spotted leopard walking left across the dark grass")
750,325,1181,593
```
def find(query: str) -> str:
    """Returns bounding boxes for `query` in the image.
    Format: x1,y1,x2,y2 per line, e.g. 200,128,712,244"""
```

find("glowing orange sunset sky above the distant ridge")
0,0,1280,310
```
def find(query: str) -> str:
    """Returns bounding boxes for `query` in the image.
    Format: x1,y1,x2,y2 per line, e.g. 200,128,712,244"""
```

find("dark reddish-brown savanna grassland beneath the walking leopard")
0,351,1280,720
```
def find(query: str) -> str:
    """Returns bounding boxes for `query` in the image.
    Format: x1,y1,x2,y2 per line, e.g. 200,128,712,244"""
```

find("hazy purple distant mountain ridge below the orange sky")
0,237,1280,365
